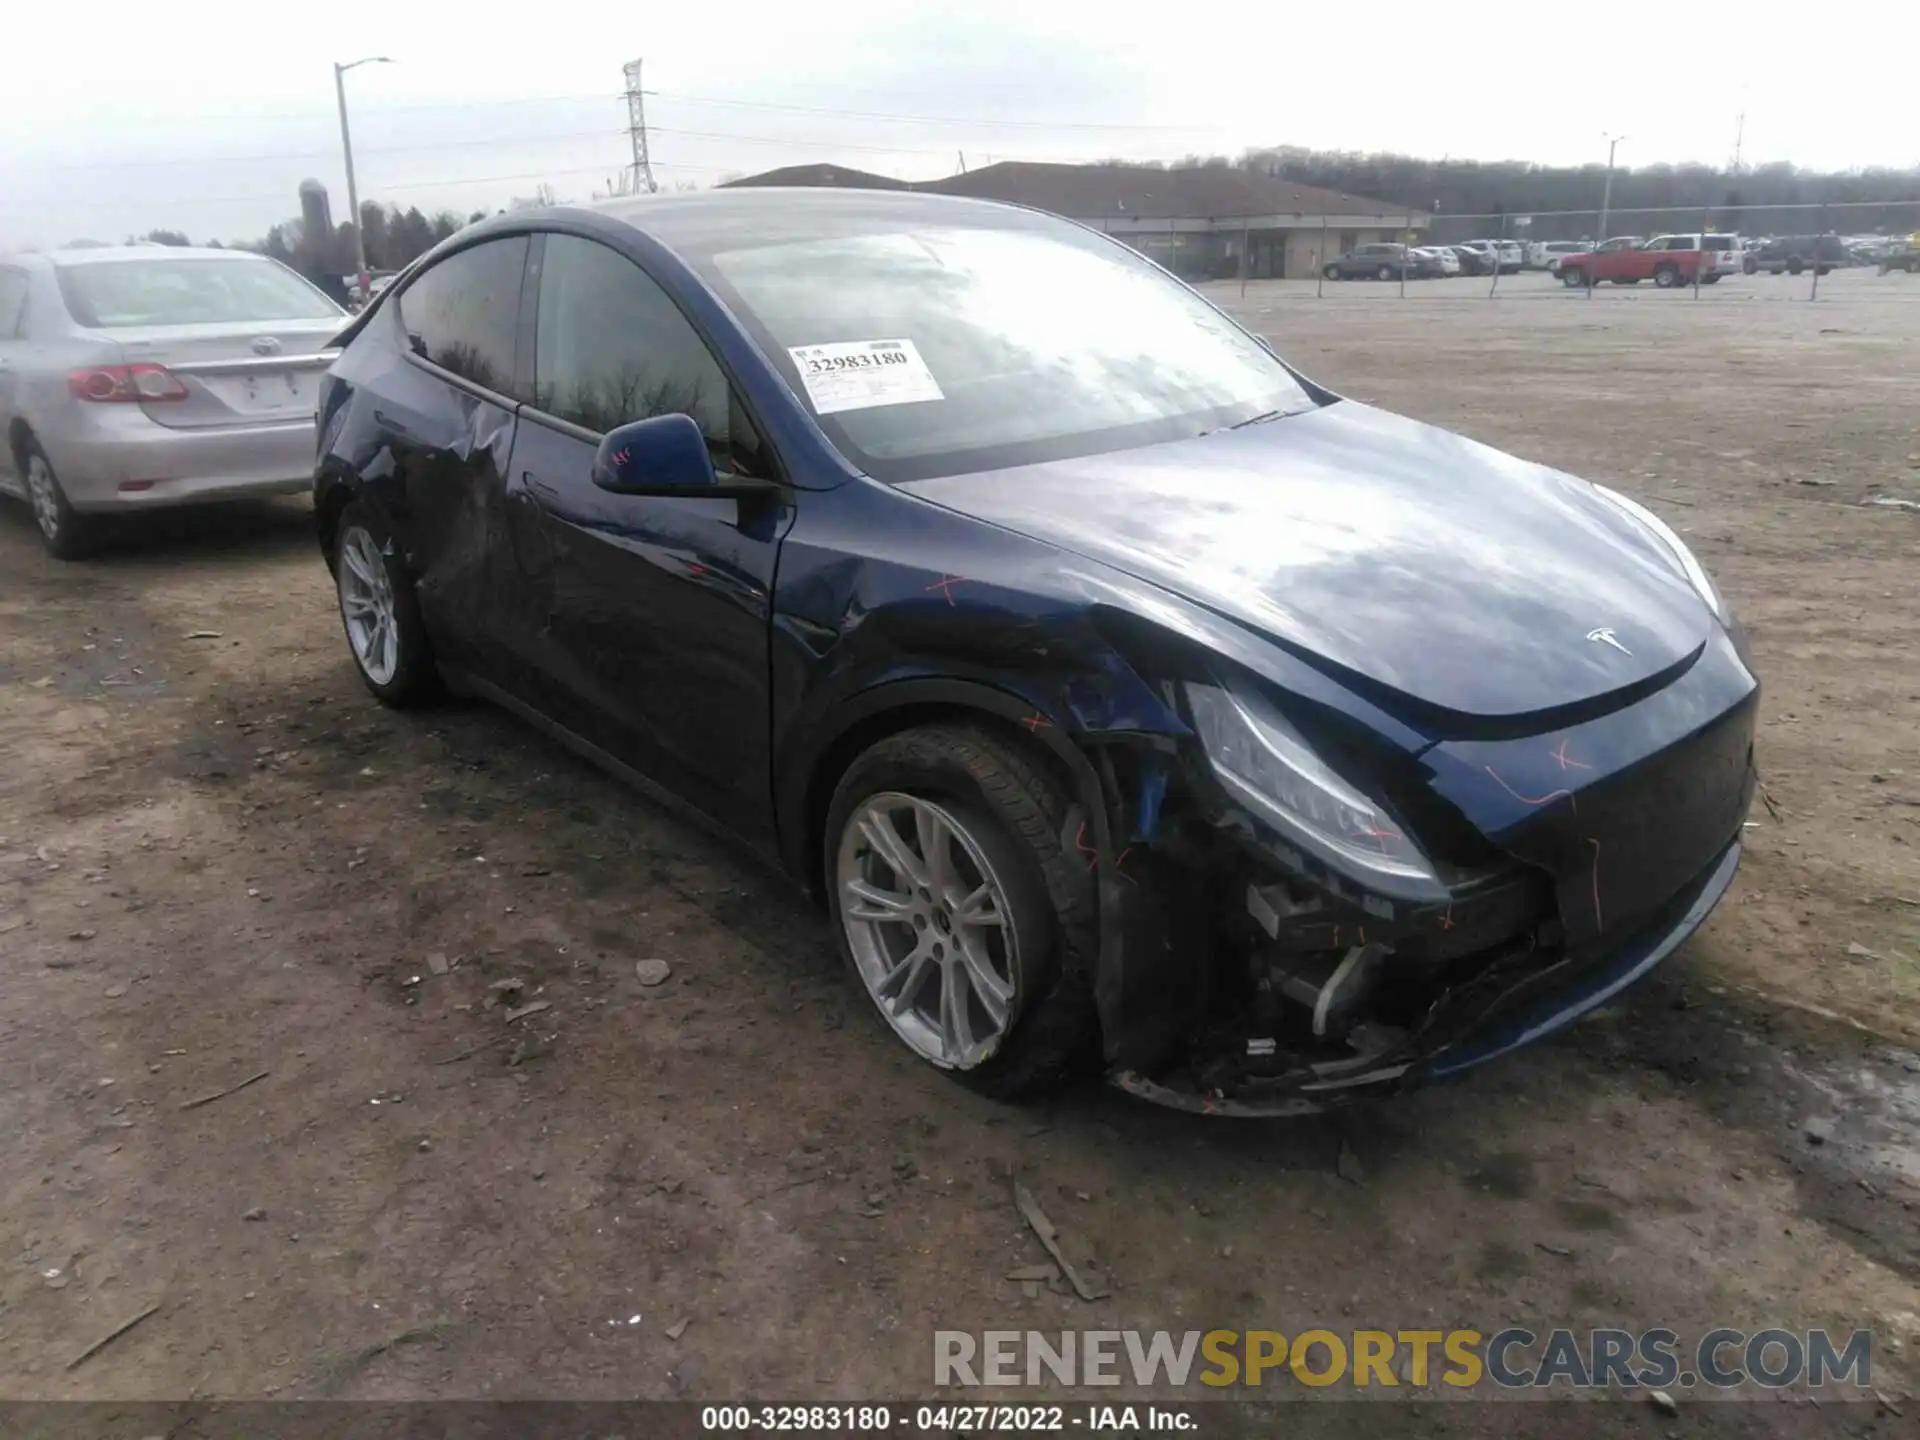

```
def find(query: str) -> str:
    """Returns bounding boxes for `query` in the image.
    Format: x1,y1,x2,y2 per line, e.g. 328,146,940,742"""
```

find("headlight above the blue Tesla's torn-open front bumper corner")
1185,684,1448,900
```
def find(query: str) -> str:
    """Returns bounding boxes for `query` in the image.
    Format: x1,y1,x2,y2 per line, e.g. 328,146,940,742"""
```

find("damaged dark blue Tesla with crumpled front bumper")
315,190,1759,1114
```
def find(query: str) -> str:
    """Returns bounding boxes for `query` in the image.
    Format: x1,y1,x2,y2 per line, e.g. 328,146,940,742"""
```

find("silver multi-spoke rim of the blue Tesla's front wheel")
835,791,1023,1069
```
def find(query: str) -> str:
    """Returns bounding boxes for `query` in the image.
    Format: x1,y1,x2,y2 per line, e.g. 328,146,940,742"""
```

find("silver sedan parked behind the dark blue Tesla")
0,246,348,559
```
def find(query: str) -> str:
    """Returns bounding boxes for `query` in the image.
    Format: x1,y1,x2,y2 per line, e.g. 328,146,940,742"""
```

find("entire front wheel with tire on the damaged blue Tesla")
822,724,1096,1098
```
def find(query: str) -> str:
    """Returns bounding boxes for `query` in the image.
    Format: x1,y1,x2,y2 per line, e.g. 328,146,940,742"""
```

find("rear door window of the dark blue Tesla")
396,234,528,396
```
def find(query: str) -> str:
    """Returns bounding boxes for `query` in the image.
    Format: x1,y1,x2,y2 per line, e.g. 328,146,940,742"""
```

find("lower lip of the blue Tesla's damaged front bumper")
1110,839,1740,1117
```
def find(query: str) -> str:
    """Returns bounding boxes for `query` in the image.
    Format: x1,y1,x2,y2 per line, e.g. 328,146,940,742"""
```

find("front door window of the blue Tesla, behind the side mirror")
534,234,735,463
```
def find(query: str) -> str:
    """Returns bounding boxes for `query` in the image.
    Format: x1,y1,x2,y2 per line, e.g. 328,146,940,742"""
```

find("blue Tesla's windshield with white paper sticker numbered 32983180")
703,227,1313,480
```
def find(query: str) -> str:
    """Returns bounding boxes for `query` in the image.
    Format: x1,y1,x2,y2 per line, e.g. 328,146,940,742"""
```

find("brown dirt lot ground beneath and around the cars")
0,273,1920,1434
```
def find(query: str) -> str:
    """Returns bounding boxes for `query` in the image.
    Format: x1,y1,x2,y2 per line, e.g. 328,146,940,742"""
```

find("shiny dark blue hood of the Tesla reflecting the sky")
902,401,1716,720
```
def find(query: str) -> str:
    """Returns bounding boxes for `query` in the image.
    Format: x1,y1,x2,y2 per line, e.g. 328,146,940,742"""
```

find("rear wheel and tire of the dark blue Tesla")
334,501,442,708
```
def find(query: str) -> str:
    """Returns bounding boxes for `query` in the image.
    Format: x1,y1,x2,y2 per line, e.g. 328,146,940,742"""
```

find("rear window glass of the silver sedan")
60,255,342,330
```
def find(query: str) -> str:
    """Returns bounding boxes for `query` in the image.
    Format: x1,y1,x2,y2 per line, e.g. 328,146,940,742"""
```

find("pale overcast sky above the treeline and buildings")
0,0,1920,248
